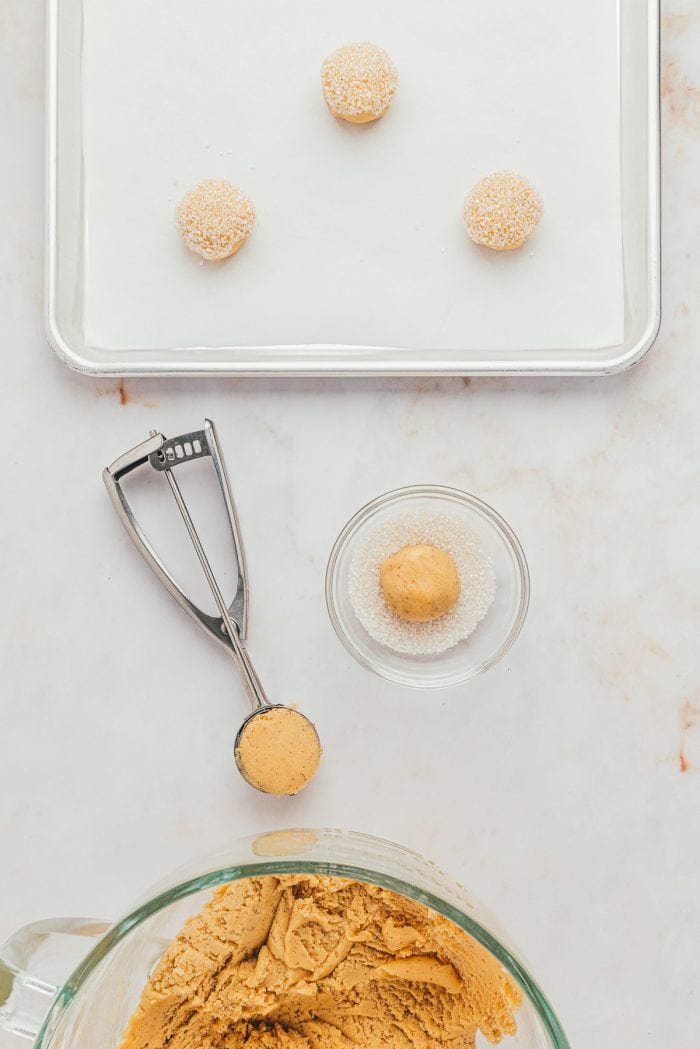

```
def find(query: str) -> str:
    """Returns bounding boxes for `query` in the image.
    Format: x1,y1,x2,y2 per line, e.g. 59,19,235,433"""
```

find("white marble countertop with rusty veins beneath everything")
0,0,700,1049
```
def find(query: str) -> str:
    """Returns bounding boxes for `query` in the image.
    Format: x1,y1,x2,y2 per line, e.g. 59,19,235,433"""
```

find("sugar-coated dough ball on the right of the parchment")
464,171,543,252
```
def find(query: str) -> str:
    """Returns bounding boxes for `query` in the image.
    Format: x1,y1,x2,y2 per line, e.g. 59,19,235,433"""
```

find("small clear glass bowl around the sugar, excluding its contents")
325,485,530,688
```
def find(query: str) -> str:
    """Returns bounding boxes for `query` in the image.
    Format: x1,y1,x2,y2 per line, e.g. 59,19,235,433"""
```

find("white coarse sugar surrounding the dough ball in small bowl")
348,510,495,656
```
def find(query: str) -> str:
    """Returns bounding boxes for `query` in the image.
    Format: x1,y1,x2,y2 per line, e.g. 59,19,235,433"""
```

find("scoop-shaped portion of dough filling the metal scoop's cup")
236,707,321,794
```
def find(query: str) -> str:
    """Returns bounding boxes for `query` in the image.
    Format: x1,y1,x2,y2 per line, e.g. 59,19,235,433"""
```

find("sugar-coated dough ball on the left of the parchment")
175,178,255,262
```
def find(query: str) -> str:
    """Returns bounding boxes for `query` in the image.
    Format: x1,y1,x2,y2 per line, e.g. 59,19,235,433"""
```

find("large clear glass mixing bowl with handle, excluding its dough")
0,830,569,1049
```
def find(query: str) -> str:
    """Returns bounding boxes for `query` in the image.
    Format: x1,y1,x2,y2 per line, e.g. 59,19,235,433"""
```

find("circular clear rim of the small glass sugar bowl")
325,485,530,689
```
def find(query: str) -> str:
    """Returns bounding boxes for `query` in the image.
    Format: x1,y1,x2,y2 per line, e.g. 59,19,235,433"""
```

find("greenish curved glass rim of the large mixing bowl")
34,832,571,1049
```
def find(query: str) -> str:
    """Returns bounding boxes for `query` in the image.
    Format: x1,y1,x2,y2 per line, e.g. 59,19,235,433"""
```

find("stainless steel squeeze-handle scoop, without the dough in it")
102,420,316,793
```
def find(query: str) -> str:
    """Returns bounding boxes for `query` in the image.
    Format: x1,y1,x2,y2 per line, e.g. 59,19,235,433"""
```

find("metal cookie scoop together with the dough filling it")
102,420,321,794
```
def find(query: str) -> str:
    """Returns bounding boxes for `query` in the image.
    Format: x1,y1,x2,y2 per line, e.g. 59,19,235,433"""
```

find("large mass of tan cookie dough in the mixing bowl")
121,874,522,1049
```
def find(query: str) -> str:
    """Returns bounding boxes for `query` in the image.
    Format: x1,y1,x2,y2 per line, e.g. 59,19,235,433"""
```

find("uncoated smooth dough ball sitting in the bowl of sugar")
379,544,462,623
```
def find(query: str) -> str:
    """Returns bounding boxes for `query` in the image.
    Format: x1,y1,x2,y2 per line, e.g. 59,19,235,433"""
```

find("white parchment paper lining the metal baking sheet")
82,0,623,352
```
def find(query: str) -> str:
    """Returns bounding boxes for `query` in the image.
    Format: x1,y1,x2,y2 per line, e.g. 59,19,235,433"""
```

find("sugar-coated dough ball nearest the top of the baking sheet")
321,43,399,124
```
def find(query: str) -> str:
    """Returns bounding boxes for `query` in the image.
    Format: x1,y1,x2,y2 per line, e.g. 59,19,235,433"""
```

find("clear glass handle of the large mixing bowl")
0,918,111,1045
